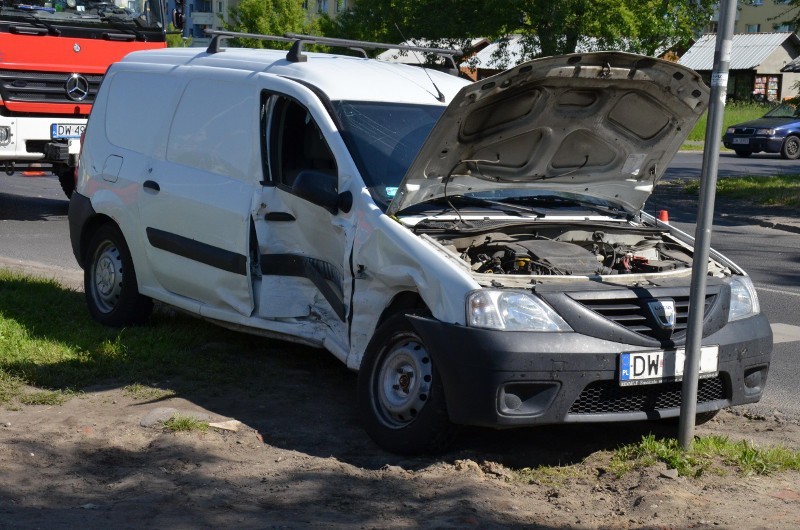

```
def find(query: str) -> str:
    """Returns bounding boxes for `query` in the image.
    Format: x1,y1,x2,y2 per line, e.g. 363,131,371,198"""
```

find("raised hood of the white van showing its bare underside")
387,52,710,215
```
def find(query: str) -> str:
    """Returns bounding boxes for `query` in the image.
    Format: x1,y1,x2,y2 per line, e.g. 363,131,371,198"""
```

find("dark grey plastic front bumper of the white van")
410,315,772,427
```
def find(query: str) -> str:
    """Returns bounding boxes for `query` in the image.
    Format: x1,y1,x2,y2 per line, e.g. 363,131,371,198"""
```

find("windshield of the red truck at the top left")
0,0,164,37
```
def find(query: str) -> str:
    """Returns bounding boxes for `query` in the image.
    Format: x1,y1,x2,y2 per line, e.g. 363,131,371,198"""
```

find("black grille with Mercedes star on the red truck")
0,70,103,105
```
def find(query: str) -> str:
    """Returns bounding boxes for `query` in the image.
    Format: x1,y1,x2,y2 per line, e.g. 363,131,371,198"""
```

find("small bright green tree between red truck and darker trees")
223,0,315,48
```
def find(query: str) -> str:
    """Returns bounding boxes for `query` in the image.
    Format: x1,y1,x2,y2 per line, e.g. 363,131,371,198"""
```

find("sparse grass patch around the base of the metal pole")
611,435,800,477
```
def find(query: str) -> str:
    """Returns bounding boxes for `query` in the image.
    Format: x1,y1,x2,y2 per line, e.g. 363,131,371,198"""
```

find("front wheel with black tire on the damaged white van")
358,313,457,455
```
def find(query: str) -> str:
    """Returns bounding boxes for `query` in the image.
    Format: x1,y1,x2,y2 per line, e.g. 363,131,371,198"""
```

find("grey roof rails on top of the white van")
206,29,463,65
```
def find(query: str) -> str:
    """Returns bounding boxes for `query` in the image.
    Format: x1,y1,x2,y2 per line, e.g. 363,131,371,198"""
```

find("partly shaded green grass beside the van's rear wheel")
0,270,296,407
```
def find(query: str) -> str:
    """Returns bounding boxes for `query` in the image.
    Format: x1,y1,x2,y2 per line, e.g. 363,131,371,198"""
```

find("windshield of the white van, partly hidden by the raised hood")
333,101,445,208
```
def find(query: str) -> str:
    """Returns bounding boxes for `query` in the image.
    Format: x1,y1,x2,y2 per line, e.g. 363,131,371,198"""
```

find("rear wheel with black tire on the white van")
83,224,153,327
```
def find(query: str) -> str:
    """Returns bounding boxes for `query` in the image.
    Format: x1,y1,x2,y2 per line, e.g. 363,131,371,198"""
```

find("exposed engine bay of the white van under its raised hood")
429,225,692,276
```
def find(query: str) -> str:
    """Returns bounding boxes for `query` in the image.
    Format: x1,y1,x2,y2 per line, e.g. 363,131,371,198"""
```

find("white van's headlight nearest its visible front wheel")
467,289,572,331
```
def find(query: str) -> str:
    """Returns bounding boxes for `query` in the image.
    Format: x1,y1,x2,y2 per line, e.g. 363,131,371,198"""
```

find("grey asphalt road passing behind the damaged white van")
0,159,800,418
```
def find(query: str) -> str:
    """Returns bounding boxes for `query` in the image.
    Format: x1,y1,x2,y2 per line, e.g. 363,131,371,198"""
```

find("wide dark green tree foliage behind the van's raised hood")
321,0,720,63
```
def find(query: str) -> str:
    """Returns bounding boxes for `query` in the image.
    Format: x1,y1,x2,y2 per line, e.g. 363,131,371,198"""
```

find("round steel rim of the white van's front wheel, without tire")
376,338,433,428
